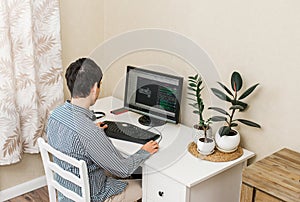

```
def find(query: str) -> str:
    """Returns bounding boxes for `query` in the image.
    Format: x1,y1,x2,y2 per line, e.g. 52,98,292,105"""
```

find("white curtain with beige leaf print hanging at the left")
0,0,64,165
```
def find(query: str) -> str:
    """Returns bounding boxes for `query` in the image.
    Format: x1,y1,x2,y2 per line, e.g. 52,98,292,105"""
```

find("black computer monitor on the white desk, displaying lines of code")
124,66,183,126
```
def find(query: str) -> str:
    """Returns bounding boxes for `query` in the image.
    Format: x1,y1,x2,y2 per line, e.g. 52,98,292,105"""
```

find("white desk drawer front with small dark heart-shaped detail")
143,168,186,202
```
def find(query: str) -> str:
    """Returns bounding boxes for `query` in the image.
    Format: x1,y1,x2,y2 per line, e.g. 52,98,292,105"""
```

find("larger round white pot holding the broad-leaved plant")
215,128,241,153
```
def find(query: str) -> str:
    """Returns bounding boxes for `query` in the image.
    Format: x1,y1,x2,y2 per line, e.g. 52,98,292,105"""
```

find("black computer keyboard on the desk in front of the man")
103,121,160,144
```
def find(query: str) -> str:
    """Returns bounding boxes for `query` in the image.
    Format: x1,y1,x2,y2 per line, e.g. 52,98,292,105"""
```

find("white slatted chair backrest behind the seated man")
38,138,90,202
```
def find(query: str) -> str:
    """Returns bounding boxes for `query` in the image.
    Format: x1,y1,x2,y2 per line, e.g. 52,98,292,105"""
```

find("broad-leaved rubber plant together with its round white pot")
208,71,261,152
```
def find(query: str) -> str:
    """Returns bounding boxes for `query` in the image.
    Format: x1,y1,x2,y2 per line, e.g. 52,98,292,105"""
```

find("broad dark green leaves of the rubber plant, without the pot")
208,71,261,137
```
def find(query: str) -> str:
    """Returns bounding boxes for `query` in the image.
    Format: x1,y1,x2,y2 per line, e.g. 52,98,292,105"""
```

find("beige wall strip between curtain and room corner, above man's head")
60,0,104,98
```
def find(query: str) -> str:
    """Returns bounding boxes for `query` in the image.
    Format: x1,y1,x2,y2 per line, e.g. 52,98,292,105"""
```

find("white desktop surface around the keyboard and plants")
91,97,254,187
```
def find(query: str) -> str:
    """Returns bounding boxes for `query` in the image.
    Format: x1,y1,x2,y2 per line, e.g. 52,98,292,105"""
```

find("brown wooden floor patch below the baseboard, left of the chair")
6,186,49,202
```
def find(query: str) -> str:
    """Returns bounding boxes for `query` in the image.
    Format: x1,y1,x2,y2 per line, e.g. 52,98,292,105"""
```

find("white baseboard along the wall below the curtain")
0,176,47,201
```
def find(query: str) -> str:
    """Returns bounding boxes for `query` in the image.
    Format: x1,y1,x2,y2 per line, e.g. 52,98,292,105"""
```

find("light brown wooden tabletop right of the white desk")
243,148,300,201
